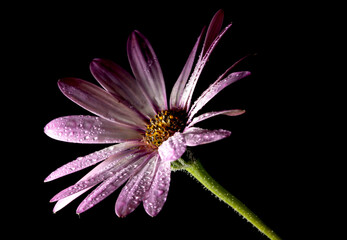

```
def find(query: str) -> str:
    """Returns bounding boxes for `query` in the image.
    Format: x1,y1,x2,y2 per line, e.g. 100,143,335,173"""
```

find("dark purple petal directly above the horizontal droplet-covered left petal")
58,78,146,129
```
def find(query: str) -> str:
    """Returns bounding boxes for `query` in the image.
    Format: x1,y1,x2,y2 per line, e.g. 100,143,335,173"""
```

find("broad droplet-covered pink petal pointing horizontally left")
44,115,142,143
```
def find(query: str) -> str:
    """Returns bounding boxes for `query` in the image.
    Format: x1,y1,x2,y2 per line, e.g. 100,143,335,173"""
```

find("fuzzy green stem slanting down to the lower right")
178,158,281,240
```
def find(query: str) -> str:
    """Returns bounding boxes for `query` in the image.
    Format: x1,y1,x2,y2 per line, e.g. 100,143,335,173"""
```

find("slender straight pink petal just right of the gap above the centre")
170,31,203,109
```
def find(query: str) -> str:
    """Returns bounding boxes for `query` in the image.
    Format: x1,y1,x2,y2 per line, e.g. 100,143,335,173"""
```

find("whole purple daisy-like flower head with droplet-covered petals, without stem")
44,10,250,217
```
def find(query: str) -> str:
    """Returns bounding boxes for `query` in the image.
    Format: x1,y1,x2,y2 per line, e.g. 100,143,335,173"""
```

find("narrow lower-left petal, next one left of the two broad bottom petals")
76,152,148,214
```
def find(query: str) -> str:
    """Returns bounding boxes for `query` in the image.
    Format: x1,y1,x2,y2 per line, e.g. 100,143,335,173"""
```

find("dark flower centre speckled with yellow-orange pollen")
145,110,186,147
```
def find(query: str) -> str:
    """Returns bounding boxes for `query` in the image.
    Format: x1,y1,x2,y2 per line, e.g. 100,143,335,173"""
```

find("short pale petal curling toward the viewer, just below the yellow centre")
158,132,186,162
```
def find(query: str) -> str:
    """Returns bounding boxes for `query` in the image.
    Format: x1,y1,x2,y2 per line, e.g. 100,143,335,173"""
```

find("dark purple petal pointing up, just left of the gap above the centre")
127,31,167,112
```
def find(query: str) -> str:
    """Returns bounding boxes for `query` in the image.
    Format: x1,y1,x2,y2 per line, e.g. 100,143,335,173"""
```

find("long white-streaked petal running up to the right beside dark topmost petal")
180,21,231,109
